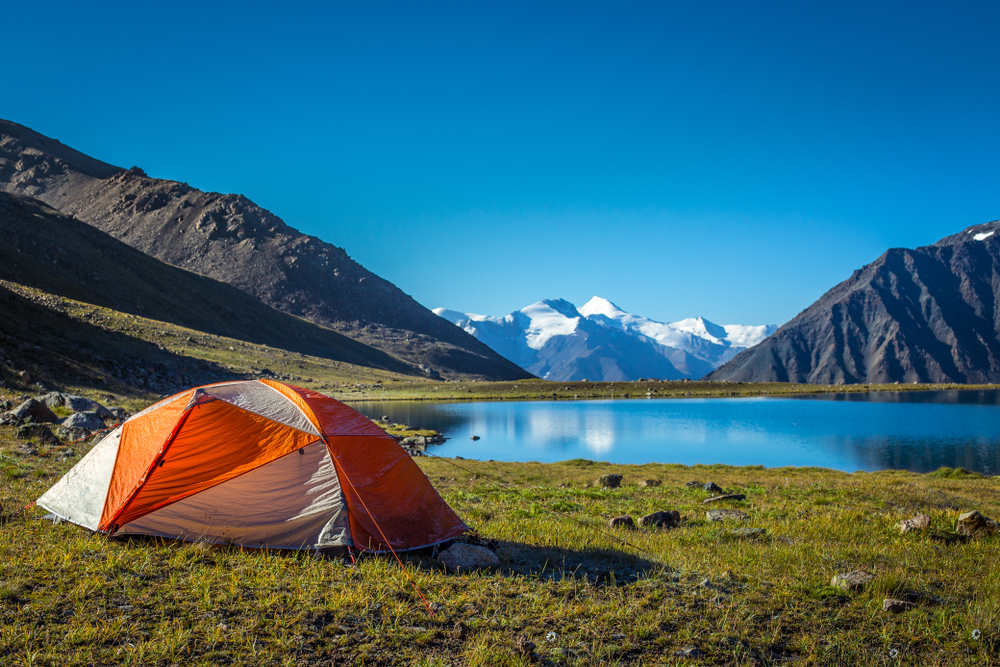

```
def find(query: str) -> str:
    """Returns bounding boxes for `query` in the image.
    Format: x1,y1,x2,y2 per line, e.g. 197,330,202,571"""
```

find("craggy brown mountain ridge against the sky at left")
0,120,528,379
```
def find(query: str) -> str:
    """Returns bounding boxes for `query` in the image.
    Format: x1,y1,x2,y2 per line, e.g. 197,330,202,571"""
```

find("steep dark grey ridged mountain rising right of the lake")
709,221,1000,384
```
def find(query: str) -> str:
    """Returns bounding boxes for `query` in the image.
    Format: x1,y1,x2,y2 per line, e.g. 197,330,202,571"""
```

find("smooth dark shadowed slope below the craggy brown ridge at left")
0,192,410,374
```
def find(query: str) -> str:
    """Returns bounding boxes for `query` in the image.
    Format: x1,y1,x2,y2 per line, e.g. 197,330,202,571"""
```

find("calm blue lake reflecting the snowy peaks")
352,391,1000,474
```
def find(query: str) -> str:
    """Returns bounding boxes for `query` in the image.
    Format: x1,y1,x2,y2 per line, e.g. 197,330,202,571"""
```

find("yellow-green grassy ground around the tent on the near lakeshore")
0,428,1000,666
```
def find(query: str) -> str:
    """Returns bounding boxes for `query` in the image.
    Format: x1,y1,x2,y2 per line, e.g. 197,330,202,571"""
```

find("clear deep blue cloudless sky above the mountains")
0,1,1000,324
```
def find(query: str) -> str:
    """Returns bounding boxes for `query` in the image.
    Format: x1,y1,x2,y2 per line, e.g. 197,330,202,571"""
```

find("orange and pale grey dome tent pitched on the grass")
38,380,468,551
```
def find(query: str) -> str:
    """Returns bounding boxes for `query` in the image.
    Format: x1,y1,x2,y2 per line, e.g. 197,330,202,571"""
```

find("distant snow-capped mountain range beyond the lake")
434,296,778,381
